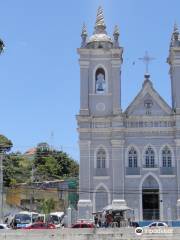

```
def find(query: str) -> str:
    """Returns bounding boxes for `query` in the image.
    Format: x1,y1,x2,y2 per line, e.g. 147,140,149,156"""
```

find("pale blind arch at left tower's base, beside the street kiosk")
95,187,108,212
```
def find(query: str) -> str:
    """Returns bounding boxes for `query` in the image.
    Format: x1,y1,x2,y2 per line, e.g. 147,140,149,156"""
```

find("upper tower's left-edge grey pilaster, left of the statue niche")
79,60,89,115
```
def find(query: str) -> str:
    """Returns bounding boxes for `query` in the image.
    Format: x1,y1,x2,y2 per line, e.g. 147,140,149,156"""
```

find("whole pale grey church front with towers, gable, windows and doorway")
77,7,180,220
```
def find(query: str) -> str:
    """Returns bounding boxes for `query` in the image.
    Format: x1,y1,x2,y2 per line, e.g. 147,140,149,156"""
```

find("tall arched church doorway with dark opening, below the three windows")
142,176,160,220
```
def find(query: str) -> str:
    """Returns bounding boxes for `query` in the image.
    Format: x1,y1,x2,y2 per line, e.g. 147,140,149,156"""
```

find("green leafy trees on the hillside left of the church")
0,140,79,186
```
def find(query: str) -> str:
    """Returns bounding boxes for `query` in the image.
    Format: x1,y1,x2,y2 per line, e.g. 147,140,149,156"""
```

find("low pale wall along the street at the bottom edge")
0,228,180,240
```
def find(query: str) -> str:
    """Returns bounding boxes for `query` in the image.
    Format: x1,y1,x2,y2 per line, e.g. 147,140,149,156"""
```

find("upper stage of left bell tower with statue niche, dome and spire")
78,7,123,116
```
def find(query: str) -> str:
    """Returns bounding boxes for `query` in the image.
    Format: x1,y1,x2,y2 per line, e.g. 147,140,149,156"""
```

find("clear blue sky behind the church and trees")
0,0,180,160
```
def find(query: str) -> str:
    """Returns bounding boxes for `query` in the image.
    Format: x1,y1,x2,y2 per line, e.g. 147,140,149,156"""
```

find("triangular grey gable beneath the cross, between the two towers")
125,75,172,116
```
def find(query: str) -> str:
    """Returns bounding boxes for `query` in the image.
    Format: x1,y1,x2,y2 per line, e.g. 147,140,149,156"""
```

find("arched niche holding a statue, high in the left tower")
95,68,106,93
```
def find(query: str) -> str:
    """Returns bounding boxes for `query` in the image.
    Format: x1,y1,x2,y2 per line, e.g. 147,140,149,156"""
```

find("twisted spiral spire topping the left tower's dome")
94,6,106,34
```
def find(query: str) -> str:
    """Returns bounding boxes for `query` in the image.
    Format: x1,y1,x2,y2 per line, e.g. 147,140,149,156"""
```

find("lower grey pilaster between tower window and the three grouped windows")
111,140,124,200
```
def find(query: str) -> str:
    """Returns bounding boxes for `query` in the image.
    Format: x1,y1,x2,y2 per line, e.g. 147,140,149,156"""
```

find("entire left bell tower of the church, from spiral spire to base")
77,7,123,219
